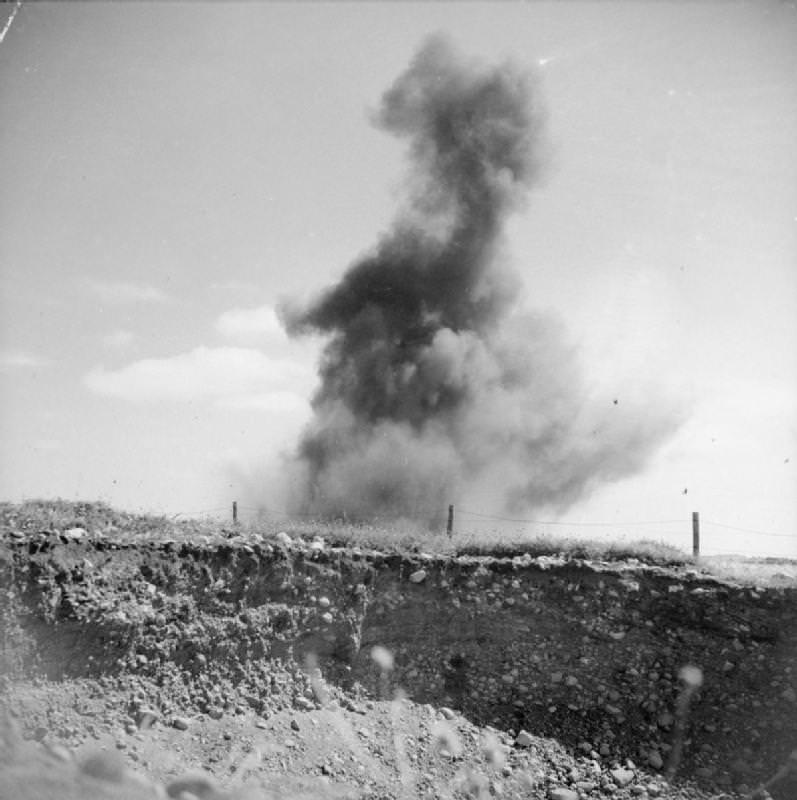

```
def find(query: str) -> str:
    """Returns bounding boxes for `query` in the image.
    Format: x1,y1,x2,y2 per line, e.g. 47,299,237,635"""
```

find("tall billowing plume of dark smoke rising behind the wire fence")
282,37,671,518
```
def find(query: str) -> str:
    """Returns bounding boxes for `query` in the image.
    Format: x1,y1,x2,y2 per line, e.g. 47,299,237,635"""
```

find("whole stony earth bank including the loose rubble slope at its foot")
0,510,797,800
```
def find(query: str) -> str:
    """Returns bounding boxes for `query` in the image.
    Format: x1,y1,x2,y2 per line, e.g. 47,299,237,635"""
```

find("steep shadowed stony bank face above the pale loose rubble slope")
0,532,797,797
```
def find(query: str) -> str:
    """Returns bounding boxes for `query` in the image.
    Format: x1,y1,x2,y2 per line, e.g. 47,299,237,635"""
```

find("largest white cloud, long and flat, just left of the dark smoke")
84,347,313,408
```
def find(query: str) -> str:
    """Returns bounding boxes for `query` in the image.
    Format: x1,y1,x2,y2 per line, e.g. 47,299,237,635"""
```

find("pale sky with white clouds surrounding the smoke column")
0,0,797,557
